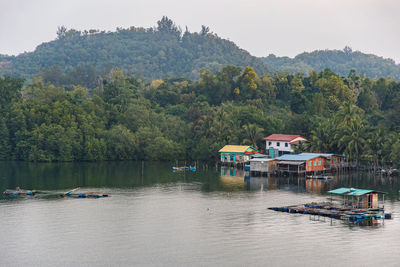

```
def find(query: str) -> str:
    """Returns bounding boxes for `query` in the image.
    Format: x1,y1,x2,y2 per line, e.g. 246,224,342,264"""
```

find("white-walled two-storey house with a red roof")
264,134,308,158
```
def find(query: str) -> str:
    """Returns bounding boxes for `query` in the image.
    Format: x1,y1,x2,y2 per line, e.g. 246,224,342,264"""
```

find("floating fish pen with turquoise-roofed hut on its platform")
269,188,392,222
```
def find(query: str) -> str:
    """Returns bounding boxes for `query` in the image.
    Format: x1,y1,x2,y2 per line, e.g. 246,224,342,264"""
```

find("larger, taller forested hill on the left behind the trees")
0,17,272,79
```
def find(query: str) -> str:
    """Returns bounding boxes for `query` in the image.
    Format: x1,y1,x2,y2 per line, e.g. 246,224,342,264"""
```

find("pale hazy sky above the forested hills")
0,0,400,63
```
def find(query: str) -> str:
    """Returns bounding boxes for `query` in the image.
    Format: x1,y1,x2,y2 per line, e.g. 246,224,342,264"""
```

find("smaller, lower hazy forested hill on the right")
262,47,400,80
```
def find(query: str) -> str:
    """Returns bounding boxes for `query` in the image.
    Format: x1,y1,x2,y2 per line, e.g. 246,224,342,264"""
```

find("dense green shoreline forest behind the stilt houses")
0,66,400,166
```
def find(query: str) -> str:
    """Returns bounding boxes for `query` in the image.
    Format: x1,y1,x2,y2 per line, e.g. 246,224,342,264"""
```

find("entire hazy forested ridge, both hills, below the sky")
0,17,400,81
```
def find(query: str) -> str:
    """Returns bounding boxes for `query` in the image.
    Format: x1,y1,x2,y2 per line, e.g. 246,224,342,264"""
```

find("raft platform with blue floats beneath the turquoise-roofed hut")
268,202,392,222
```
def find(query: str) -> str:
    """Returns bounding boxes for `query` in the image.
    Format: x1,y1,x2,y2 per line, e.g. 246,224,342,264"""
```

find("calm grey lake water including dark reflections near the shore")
0,162,400,266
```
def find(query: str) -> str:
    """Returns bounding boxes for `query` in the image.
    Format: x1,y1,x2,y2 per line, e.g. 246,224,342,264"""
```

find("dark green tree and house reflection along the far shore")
0,161,399,200
